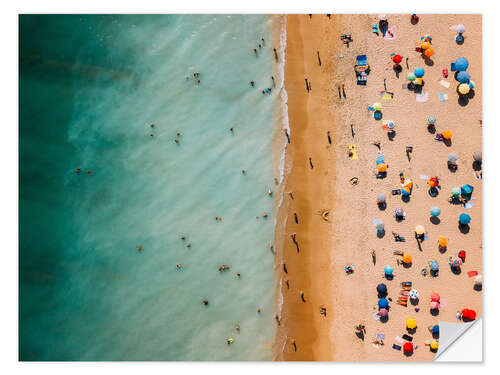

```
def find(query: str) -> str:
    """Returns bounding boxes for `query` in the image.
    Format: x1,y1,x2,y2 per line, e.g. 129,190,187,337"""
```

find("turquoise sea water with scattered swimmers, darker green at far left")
19,15,280,360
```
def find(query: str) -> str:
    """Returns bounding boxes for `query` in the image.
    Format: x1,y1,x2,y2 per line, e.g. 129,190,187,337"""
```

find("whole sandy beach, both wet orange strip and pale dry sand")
274,14,482,361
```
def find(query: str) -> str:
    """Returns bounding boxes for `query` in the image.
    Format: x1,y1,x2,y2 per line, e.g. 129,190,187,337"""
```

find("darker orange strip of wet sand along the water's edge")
273,15,335,361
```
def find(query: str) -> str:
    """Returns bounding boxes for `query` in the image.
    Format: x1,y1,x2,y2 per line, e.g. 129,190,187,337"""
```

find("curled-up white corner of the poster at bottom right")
434,318,483,362
